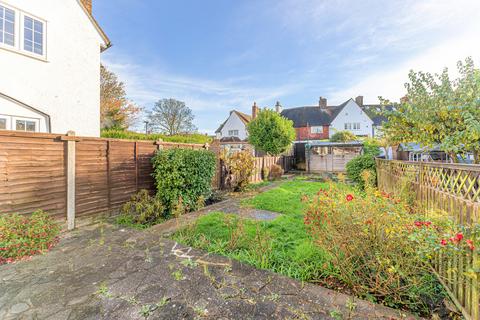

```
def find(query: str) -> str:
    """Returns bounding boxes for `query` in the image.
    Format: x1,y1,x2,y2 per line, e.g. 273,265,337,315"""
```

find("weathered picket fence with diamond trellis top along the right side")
377,159,480,320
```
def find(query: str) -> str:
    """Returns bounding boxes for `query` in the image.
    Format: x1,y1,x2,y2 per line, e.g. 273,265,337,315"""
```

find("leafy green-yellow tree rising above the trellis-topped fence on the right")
380,58,480,164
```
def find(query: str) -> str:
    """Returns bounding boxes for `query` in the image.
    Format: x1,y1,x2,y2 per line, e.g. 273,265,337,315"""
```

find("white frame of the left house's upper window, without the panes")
0,0,48,62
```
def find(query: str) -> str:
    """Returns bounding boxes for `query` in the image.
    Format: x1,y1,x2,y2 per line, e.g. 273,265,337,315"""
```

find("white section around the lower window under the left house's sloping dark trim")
0,96,49,132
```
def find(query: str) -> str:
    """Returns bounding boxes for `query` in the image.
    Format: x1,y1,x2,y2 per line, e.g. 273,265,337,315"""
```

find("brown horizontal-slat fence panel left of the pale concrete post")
0,132,66,216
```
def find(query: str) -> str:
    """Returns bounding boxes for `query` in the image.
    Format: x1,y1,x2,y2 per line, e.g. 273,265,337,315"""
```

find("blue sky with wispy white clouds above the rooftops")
93,0,480,133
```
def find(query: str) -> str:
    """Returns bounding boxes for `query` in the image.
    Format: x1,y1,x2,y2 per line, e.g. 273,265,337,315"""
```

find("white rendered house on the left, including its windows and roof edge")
0,0,110,136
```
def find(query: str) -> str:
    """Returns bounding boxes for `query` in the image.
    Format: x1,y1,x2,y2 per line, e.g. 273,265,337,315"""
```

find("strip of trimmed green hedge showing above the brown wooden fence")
102,130,212,144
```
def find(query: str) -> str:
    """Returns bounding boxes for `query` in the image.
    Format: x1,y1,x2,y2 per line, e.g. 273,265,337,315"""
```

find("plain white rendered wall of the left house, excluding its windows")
0,0,102,136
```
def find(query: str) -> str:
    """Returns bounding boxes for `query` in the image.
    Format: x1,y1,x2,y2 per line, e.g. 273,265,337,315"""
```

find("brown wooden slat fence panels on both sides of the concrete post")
0,131,205,224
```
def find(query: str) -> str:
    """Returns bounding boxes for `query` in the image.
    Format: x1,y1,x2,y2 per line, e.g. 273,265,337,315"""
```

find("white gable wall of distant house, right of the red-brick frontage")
330,99,373,137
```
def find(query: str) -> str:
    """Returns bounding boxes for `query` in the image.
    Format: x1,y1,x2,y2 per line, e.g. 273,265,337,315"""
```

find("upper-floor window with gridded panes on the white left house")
0,0,47,60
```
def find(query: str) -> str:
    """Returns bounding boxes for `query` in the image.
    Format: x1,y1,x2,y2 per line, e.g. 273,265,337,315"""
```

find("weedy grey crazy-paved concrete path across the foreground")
0,224,414,320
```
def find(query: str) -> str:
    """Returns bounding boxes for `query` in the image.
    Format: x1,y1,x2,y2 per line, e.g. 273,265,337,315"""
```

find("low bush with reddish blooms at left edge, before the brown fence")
0,211,60,264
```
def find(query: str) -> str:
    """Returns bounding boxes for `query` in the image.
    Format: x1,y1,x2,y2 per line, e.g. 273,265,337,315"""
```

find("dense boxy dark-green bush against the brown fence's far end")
152,149,216,215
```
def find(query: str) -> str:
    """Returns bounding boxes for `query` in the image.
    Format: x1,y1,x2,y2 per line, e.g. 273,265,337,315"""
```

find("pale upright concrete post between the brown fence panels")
65,131,76,230
